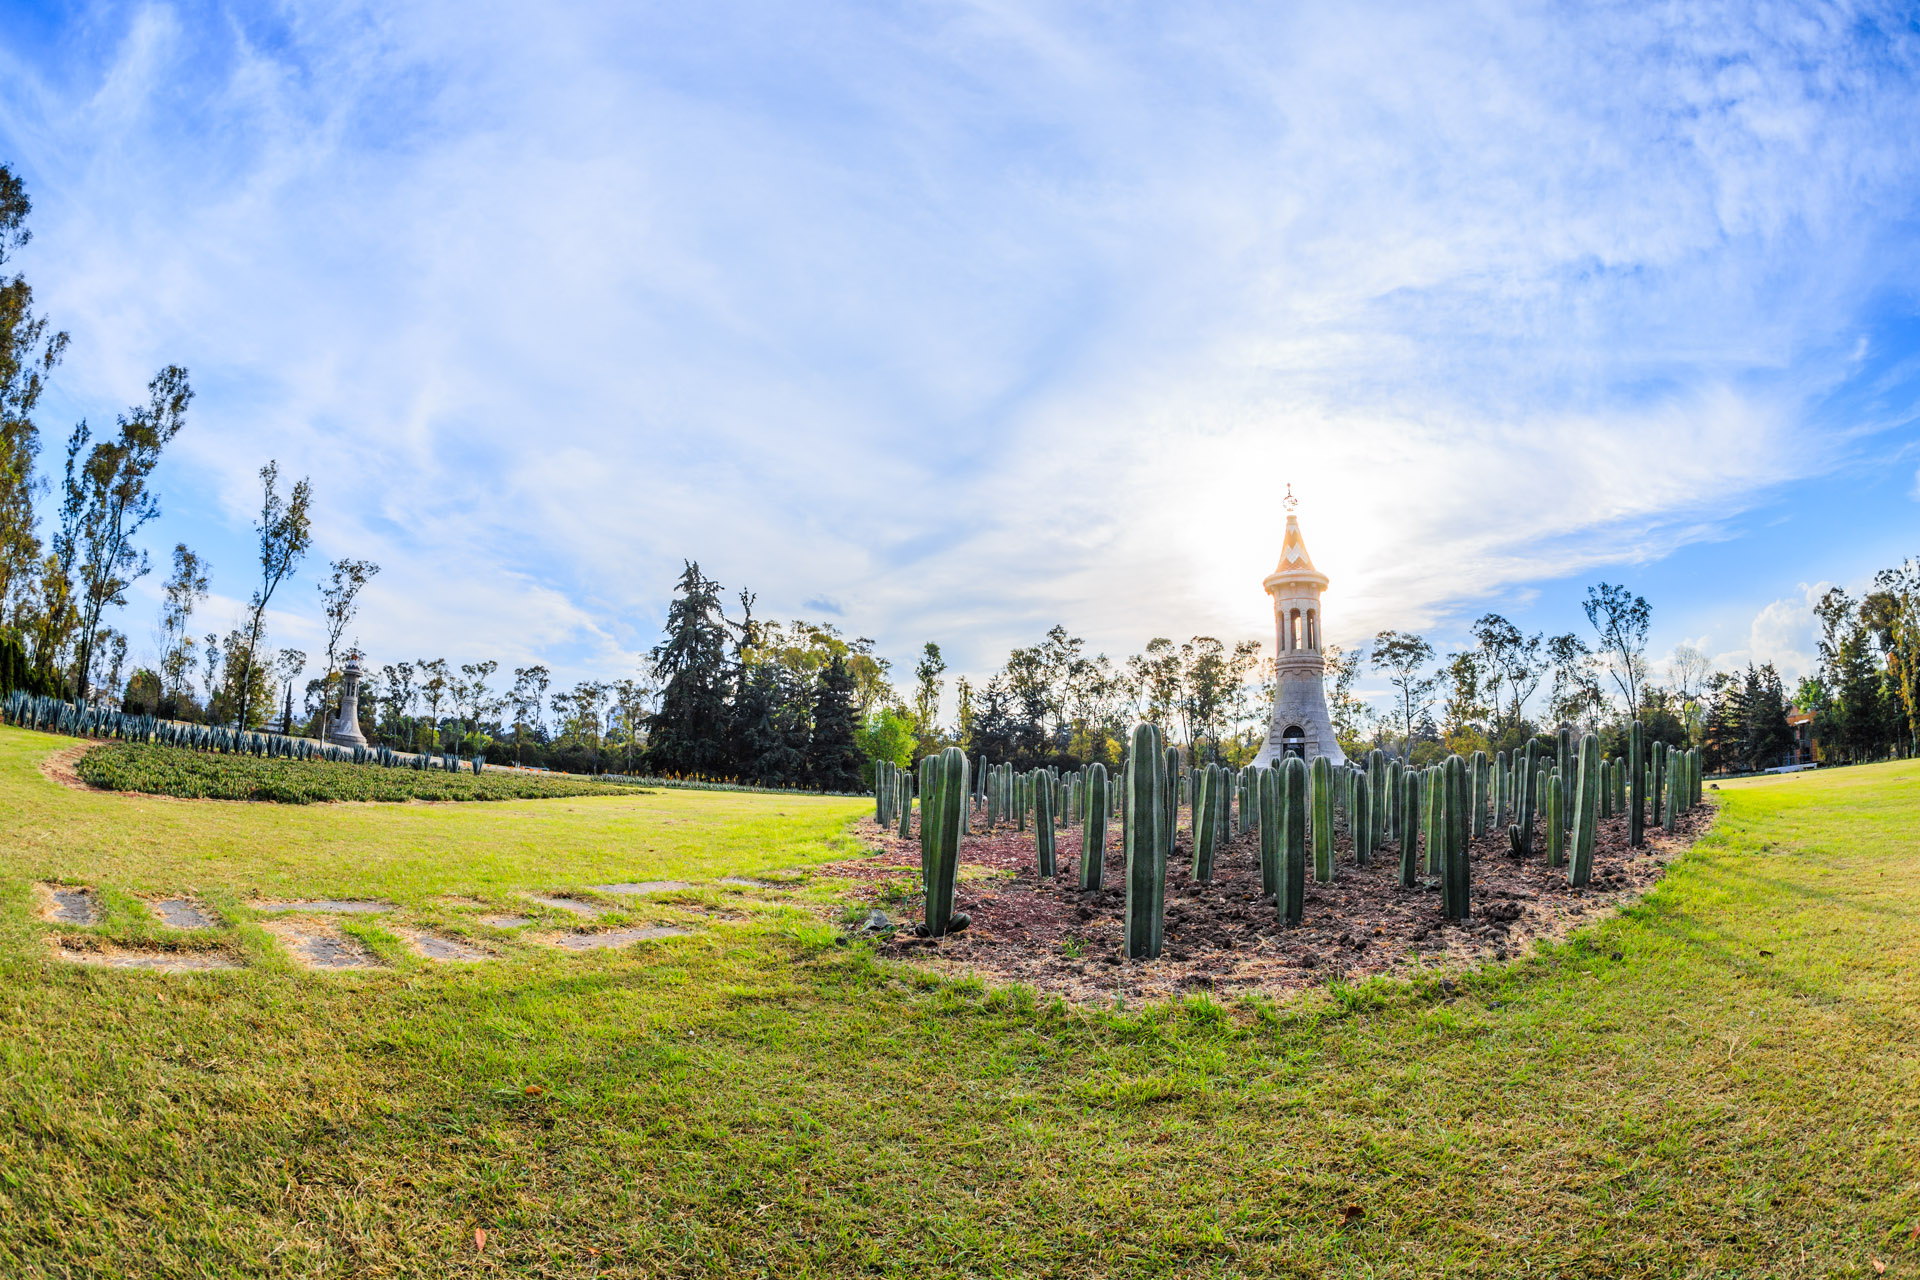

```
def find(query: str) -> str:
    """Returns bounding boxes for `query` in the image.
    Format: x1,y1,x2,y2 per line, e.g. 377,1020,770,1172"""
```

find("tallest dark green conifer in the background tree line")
647,560,730,773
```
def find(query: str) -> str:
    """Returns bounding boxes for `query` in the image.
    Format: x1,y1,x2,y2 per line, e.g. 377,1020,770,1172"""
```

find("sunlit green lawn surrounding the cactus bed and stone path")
0,731,1920,1276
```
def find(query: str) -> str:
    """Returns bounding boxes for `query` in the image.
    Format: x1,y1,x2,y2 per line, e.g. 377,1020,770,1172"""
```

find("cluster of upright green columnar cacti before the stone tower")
902,722,1703,960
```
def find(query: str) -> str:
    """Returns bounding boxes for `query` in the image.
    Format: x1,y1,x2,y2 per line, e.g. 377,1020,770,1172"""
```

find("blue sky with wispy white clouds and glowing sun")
0,2,1920,710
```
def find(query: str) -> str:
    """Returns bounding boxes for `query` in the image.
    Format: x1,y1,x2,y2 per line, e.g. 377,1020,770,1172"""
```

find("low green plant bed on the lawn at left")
75,743,645,804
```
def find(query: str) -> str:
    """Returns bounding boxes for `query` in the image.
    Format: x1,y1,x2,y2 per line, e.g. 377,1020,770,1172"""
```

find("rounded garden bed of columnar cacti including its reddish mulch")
833,725,1711,1000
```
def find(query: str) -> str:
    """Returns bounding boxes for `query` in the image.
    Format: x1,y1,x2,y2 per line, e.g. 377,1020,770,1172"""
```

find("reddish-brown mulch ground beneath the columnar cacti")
833,808,1713,1002
